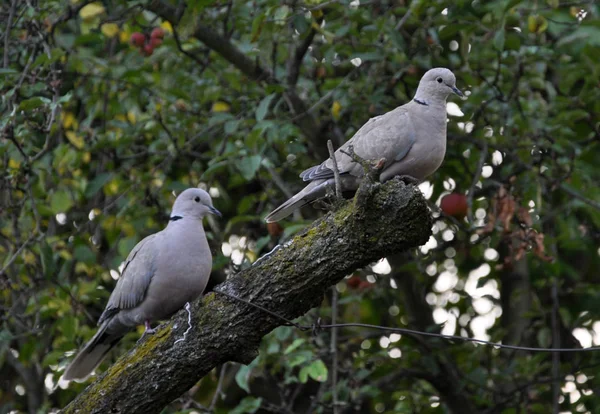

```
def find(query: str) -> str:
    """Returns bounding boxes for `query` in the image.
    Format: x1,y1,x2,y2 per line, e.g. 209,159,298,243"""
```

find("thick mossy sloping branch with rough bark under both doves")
63,180,432,414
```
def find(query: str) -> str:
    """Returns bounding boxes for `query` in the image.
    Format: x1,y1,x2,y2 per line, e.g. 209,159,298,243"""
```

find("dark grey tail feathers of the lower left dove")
63,321,123,381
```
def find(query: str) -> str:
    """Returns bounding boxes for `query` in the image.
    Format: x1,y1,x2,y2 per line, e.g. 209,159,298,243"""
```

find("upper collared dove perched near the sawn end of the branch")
265,68,463,223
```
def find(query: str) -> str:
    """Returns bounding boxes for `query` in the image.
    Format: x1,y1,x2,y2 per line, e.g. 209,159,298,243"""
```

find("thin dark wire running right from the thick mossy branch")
214,290,600,353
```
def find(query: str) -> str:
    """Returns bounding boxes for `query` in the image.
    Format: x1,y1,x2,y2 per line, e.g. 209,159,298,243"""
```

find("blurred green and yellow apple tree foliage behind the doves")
0,0,600,414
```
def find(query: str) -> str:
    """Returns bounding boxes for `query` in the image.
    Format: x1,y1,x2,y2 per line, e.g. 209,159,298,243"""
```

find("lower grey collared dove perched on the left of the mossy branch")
63,188,221,380
